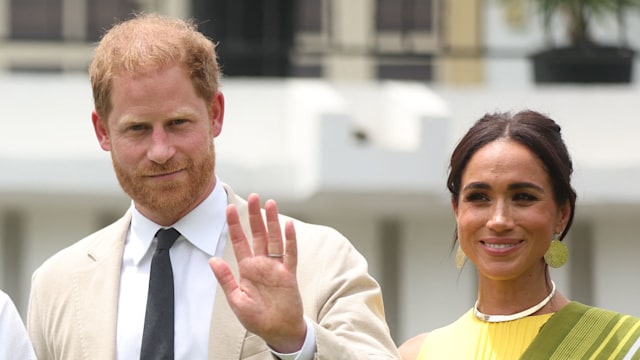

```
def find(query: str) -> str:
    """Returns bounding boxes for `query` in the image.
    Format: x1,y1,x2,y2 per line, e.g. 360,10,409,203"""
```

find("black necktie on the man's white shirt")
140,228,180,360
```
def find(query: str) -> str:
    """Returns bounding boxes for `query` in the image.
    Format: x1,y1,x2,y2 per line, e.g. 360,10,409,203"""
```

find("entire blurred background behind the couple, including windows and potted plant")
0,0,640,343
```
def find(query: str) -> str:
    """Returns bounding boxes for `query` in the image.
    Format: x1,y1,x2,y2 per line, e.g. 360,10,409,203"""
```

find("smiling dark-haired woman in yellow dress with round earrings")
400,111,640,360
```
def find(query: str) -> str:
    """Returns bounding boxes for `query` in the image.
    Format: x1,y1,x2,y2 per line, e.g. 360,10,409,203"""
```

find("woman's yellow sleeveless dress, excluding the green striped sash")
417,309,553,360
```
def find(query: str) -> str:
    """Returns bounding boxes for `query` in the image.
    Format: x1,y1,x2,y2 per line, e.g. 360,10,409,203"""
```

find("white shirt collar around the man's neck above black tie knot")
127,178,227,265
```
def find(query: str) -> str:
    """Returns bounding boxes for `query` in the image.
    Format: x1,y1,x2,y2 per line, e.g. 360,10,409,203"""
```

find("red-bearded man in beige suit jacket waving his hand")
27,11,399,360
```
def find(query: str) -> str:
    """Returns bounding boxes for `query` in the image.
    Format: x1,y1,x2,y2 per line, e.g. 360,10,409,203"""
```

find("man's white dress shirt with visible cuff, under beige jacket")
116,179,316,360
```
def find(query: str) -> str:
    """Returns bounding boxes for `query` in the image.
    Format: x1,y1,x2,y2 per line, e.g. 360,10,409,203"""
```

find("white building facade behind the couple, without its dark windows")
0,0,640,343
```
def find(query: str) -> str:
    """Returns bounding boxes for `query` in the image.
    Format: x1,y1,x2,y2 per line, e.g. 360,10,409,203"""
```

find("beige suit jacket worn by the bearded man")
27,186,399,360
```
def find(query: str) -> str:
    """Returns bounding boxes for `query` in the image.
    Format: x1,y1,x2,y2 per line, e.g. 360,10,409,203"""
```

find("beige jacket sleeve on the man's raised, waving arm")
295,222,400,360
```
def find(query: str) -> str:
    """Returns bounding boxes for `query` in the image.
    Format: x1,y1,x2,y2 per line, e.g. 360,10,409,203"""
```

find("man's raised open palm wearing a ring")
209,194,306,353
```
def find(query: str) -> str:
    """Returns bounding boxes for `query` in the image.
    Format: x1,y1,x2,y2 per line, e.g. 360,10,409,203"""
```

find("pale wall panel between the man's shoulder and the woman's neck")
398,214,477,343
